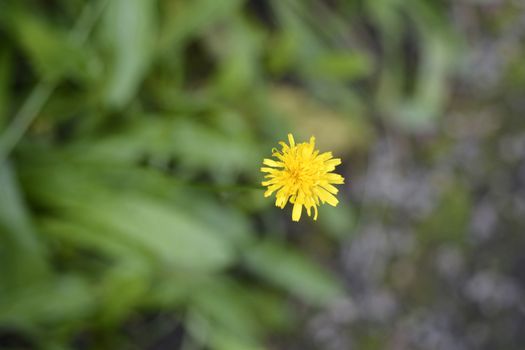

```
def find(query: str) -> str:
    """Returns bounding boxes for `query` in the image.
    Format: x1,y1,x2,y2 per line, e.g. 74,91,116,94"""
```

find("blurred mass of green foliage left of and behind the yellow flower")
0,0,458,350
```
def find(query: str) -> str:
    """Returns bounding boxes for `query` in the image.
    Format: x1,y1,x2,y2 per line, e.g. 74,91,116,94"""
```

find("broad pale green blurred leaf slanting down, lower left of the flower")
19,159,234,271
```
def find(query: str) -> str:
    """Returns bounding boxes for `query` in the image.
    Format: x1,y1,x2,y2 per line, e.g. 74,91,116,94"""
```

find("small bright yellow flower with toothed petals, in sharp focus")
261,134,344,221
